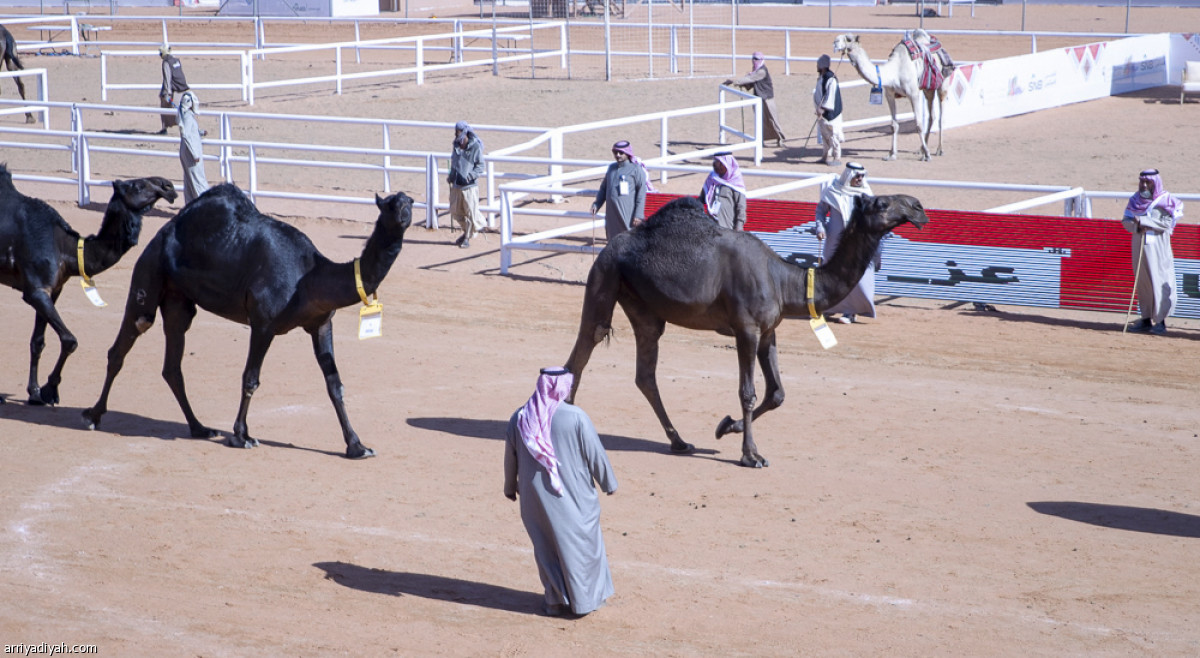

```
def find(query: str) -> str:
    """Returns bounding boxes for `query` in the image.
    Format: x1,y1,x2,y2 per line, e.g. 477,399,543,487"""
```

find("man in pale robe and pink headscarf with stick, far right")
1121,169,1183,336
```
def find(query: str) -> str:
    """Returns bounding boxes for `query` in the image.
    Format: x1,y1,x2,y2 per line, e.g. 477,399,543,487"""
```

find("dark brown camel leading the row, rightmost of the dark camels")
566,195,928,467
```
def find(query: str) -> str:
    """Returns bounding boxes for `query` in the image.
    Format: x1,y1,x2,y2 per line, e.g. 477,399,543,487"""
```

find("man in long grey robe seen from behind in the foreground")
504,367,617,616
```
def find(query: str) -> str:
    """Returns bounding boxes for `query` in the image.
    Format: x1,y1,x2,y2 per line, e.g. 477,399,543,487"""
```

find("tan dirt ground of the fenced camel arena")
0,6,1200,657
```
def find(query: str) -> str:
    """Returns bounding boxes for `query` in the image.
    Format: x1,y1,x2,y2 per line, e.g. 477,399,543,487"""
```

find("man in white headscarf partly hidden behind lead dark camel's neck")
816,162,883,324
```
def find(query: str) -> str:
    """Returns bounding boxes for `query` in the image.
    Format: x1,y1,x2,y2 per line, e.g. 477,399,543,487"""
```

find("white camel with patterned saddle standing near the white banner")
833,30,949,160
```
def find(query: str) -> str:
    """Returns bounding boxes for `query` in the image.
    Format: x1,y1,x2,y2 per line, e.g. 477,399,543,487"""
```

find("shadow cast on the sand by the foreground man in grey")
313,562,545,615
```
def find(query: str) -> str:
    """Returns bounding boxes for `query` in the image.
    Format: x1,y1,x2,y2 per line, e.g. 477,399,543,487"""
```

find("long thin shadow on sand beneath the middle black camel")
0,401,346,457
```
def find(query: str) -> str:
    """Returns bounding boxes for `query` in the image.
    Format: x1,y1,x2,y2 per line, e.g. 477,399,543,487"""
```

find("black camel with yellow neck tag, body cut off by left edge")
0,165,175,405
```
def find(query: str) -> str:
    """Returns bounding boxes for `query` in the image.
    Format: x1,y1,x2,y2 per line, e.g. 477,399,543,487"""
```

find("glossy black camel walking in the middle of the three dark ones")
83,184,413,459
